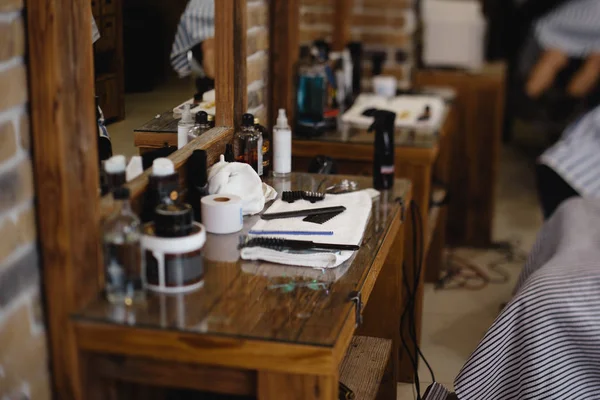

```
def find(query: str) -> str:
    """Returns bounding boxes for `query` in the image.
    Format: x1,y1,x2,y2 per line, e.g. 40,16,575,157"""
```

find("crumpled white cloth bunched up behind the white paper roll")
208,156,277,215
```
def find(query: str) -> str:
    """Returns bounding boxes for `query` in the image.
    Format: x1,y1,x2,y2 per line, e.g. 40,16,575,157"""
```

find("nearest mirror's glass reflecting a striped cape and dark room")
92,0,216,193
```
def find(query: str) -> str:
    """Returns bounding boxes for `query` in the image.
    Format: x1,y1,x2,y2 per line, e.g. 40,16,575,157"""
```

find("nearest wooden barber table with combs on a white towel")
73,174,411,400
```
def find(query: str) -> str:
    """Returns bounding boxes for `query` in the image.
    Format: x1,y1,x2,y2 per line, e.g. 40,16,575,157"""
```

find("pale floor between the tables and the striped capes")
398,148,542,400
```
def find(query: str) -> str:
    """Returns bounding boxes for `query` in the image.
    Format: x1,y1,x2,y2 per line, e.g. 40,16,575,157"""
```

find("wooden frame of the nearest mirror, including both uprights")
25,0,247,399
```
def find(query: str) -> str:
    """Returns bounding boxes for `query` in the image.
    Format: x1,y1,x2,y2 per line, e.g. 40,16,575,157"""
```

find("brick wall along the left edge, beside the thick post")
0,0,50,400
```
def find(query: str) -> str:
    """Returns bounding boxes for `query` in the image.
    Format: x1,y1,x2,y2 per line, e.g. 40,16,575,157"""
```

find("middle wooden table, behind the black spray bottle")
292,106,455,382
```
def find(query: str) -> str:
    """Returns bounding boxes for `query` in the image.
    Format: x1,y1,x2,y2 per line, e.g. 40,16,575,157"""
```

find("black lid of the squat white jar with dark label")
154,204,194,237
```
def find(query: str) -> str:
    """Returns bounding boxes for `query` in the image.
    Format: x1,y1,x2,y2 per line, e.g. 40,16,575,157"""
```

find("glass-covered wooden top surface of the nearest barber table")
74,173,410,347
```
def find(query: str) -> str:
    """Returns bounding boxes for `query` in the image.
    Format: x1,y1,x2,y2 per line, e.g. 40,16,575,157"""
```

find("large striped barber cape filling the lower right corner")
454,197,600,400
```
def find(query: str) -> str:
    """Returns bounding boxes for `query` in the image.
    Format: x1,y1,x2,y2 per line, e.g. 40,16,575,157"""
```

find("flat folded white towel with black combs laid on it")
241,191,372,268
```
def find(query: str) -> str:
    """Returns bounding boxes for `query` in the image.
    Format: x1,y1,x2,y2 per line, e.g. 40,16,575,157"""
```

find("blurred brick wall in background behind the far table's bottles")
300,0,416,89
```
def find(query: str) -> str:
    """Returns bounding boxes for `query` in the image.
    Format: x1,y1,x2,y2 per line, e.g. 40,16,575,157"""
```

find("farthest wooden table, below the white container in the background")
415,63,506,246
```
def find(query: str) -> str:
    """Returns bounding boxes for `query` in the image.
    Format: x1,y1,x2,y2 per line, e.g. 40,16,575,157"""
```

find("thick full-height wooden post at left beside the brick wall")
27,0,101,399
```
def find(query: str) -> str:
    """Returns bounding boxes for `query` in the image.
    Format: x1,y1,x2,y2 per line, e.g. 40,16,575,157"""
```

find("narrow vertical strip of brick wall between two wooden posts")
247,0,271,125
